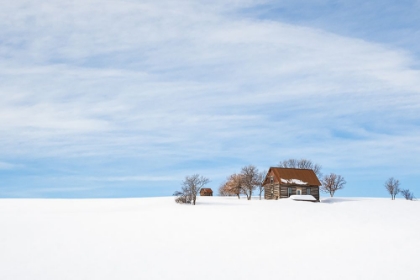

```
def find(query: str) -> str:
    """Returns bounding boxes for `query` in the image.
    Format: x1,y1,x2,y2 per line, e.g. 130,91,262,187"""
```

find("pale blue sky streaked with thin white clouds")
0,0,420,198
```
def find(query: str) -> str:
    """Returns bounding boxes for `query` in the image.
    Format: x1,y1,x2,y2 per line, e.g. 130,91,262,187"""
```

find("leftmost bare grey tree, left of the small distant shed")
174,174,210,205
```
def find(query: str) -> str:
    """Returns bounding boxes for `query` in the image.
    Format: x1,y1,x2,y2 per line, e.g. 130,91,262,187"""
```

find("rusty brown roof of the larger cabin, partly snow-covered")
266,167,321,186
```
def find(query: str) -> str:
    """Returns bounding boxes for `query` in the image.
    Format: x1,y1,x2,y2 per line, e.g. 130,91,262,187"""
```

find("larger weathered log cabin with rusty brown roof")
263,167,321,201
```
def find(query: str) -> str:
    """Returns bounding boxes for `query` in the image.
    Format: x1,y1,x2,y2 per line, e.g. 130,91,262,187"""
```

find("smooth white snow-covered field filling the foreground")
0,197,420,280
